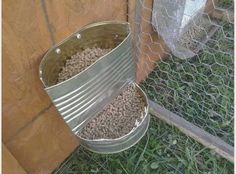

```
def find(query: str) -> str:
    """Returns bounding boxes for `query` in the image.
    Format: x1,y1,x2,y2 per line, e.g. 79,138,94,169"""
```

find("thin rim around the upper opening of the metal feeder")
39,21,131,90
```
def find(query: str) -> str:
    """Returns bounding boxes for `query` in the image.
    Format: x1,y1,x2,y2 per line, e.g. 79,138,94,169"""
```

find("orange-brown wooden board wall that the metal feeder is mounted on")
3,0,127,174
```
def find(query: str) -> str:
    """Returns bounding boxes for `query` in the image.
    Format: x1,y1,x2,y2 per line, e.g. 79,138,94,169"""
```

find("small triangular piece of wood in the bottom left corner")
2,144,26,174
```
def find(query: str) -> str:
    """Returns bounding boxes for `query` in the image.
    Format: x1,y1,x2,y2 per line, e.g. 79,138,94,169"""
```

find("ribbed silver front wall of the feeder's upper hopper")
50,36,135,132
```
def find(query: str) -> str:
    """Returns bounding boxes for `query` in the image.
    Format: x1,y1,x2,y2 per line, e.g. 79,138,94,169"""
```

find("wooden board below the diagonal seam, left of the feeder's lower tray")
6,106,79,174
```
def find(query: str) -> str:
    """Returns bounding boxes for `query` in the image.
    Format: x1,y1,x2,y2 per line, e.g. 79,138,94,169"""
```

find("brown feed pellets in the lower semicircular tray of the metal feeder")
79,84,145,139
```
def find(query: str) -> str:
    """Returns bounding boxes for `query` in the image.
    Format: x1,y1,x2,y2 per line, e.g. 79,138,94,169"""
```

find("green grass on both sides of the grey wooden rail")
53,0,234,174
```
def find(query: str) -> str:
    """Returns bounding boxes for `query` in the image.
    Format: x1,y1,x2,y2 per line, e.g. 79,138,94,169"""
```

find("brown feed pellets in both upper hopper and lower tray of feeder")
58,47,145,139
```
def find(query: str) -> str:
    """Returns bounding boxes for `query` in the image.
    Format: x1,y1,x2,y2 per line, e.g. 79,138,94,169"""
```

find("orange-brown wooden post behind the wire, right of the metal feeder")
128,0,168,82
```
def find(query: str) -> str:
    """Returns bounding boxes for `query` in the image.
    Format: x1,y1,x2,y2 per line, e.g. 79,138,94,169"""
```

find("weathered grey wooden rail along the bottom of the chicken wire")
149,100,234,163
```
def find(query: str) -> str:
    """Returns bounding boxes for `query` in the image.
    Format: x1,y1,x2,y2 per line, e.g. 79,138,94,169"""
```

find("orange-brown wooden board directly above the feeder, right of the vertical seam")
45,0,127,43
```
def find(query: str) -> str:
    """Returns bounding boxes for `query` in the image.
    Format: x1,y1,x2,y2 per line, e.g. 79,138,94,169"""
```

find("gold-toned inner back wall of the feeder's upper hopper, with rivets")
40,22,130,87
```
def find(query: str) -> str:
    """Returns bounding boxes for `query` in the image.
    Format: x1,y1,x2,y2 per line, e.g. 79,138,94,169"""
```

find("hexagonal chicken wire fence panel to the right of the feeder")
129,0,234,145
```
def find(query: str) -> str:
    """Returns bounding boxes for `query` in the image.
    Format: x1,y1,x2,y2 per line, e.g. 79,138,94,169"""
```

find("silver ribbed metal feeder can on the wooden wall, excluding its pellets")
39,22,149,153
